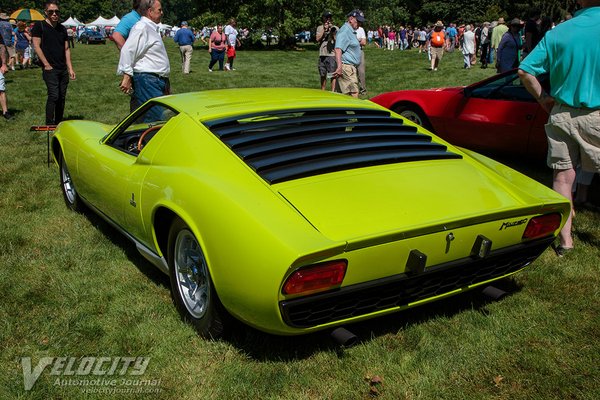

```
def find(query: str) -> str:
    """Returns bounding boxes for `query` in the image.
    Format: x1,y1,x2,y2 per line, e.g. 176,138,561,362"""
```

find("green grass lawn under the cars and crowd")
0,43,600,399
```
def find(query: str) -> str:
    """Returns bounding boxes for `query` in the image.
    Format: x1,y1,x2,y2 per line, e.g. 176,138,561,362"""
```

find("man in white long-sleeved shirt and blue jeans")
117,0,171,110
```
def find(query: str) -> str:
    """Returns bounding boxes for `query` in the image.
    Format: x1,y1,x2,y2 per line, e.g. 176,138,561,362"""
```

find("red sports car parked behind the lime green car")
371,70,549,159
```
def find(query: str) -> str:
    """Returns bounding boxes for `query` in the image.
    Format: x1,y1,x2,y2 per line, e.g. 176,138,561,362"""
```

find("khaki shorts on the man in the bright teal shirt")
546,104,600,172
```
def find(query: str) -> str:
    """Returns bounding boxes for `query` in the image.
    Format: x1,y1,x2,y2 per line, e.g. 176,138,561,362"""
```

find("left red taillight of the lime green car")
283,260,348,294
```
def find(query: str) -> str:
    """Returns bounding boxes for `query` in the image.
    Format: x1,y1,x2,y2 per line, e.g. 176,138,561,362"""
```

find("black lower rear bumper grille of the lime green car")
279,237,554,328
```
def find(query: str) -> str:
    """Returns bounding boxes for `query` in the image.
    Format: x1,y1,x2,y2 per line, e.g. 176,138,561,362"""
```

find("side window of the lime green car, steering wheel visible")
106,102,178,156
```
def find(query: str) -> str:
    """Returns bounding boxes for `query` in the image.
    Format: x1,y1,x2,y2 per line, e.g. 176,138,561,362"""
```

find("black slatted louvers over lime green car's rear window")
204,109,461,184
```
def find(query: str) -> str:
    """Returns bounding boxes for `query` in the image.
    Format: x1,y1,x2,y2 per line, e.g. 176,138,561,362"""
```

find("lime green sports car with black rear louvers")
51,89,570,337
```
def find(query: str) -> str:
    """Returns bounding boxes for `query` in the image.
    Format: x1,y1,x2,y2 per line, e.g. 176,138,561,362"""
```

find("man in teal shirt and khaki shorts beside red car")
519,0,600,256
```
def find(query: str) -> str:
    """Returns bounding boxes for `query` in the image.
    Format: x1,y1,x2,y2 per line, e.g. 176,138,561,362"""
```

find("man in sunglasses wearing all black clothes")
31,0,75,125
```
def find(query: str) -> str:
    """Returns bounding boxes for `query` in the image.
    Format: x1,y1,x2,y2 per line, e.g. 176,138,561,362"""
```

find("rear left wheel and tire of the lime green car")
168,218,227,339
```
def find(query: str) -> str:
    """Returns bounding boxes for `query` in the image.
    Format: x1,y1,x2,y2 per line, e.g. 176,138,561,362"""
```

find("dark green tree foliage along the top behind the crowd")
2,0,576,37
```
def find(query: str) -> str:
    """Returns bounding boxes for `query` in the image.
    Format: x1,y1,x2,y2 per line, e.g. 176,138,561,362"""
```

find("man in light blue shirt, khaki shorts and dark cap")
334,10,365,97
